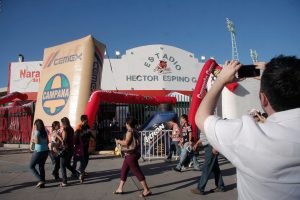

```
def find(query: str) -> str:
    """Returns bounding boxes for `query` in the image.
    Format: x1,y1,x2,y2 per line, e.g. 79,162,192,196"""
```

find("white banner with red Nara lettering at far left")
8,61,43,100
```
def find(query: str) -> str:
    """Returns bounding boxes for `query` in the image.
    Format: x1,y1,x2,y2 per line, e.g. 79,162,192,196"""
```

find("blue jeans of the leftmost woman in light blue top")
29,151,48,182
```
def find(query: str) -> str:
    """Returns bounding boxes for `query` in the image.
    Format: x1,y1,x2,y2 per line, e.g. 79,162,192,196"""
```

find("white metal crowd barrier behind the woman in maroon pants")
140,130,172,161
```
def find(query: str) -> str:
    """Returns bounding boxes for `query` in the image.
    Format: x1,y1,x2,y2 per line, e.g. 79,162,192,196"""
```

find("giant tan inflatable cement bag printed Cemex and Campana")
35,36,105,126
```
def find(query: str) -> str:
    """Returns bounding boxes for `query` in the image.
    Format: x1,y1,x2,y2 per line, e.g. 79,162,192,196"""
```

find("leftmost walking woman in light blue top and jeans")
30,119,48,188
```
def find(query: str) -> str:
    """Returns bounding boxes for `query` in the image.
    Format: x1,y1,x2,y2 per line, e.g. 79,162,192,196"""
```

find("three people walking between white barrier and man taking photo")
166,114,225,194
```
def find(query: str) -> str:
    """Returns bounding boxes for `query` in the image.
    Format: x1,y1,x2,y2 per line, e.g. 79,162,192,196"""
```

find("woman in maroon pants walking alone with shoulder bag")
114,118,151,197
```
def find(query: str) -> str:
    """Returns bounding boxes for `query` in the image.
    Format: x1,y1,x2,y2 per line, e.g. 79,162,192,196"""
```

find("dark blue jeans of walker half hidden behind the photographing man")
198,144,224,192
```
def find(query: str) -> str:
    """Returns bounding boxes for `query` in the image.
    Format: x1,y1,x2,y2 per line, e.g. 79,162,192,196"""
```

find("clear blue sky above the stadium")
0,0,300,87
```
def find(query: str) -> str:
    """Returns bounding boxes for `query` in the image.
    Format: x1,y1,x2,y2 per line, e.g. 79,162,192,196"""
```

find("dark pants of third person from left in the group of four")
60,150,78,183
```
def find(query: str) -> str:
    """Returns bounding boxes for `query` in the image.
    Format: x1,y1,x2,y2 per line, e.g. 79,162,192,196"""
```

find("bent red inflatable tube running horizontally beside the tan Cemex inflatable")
85,91,176,127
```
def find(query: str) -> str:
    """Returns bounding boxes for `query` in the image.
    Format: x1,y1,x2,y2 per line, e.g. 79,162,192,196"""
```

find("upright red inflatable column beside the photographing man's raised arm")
189,59,238,140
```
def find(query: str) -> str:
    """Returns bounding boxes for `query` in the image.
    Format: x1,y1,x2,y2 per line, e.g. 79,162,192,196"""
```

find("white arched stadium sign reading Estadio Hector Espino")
102,45,202,91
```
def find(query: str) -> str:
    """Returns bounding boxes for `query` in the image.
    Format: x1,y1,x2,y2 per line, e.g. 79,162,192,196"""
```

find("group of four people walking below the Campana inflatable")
30,115,95,188
